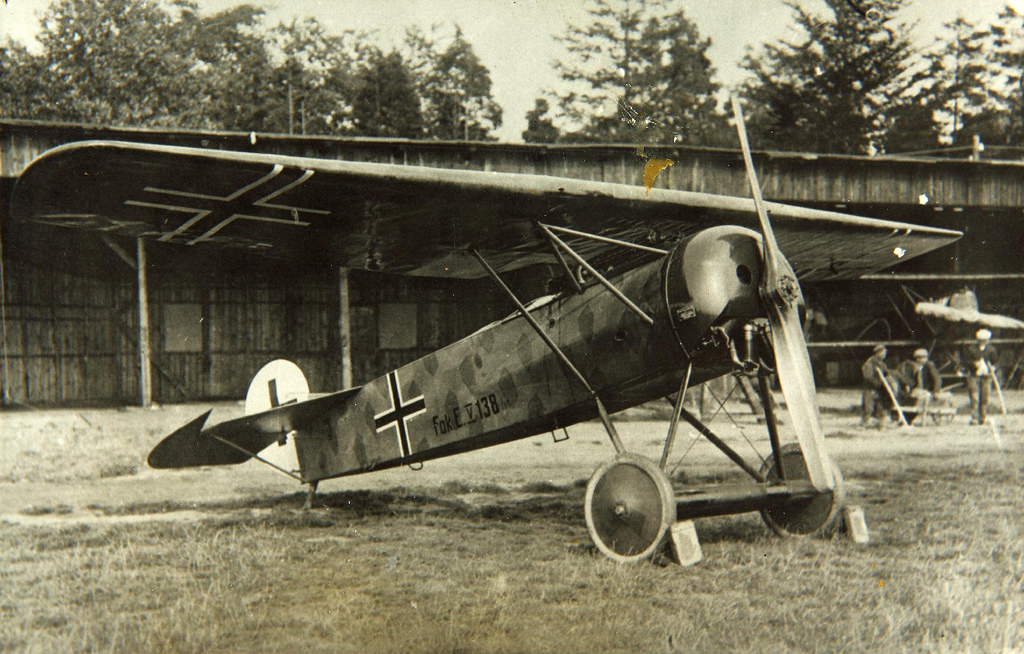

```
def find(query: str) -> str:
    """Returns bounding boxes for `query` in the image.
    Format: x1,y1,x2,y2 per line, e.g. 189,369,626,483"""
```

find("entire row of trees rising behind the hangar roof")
6,0,1024,154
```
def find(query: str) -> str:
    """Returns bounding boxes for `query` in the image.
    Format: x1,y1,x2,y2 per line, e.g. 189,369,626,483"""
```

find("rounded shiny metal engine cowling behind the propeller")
664,225,764,356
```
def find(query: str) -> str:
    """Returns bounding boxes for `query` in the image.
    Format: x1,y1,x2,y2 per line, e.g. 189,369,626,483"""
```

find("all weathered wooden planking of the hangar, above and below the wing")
0,121,1024,404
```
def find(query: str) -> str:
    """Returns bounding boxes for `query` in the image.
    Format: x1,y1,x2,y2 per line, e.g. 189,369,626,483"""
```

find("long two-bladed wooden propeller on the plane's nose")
731,96,836,490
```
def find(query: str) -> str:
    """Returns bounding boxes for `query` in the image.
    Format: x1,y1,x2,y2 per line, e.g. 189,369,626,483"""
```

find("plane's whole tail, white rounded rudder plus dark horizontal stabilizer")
148,360,359,470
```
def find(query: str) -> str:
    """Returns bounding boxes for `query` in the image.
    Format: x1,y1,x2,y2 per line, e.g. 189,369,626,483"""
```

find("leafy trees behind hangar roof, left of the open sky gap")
0,0,502,140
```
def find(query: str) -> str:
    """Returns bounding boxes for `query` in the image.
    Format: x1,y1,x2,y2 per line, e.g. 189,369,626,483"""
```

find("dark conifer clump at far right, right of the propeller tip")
739,0,1024,154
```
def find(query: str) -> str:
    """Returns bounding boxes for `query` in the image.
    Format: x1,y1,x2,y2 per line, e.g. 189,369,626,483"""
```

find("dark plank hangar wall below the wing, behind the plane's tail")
0,258,500,406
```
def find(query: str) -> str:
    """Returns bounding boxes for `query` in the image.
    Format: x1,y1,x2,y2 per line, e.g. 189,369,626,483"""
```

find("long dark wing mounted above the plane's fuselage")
11,141,959,281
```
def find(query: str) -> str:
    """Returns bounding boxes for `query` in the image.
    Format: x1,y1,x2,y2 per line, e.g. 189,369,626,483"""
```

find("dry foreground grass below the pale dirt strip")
0,452,1024,652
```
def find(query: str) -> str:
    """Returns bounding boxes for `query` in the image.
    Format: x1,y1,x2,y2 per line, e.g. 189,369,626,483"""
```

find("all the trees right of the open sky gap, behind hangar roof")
523,0,1024,154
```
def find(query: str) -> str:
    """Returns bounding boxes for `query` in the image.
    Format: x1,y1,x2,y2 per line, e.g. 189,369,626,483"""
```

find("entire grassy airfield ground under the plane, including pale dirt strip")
0,392,1024,652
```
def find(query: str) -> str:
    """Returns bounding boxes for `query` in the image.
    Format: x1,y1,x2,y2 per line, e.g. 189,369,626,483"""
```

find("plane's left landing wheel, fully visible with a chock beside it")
584,452,676,563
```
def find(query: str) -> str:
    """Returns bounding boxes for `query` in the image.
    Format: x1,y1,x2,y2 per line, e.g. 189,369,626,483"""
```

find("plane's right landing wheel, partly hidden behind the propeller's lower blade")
761,443,846,536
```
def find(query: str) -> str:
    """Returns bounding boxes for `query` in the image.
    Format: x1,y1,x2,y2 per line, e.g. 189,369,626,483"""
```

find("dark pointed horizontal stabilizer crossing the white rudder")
148,387,359,468
